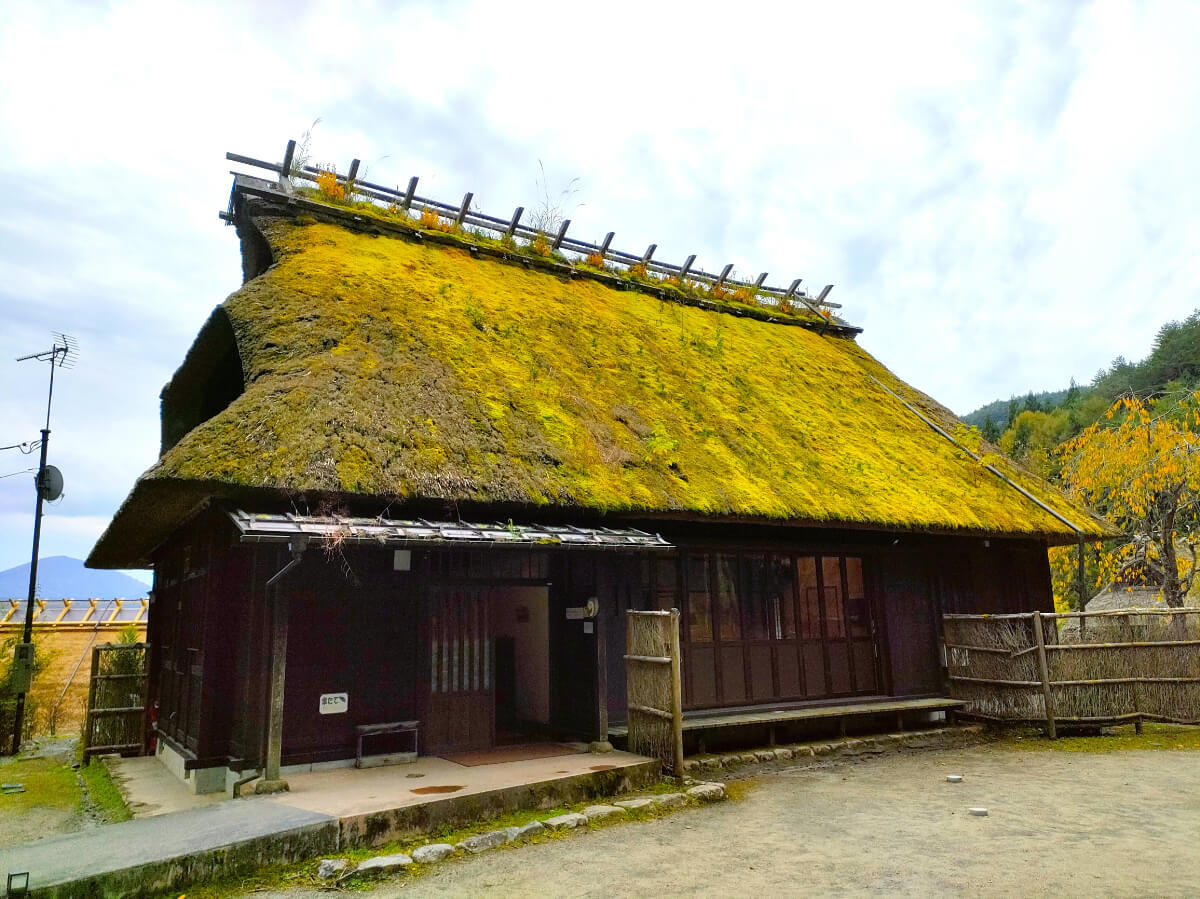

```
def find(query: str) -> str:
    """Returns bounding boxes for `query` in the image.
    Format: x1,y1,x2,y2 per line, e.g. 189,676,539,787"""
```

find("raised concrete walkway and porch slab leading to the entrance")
0,753,658,897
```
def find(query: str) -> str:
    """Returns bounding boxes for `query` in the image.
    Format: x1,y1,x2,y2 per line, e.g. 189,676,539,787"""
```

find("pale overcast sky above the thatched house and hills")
0,0,1200,576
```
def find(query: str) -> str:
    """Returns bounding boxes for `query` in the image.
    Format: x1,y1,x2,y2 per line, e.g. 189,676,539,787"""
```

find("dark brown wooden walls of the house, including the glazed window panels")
149,513,1051,768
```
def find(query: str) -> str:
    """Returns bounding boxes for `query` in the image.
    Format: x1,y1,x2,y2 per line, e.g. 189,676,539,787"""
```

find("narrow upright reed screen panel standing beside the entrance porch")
625,609,683,778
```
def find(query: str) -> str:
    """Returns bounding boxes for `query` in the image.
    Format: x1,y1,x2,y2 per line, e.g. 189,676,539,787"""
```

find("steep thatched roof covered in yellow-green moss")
89,182,1109,567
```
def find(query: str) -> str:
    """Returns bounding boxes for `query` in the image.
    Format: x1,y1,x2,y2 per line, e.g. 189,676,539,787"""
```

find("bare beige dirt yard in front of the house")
243,744,1200,899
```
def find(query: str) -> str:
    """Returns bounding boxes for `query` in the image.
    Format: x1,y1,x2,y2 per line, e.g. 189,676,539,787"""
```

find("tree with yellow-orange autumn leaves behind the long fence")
1051,391,1200,609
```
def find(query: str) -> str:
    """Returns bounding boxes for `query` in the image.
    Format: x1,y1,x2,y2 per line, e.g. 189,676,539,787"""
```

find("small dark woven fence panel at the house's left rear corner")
83,643,148,763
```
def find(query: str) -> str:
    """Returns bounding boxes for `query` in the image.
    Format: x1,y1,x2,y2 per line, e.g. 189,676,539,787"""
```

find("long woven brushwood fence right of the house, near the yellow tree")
943,609,1200,737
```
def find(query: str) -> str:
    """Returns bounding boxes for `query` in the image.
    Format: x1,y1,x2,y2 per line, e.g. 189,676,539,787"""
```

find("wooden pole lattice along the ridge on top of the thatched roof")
222,140,860,332
